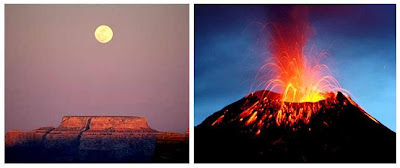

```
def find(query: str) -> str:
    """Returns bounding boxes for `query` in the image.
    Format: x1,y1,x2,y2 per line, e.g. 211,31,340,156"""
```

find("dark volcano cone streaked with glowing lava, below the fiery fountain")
195,91,396,163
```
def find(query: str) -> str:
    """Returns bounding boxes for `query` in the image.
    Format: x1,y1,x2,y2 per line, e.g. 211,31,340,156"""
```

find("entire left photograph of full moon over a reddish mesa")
5,4,189,163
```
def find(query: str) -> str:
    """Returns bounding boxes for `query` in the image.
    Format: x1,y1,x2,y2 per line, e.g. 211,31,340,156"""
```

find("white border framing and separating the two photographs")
0,0,400,168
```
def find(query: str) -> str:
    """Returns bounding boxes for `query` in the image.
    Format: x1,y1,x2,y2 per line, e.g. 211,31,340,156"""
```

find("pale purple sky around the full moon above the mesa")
5,5,189,133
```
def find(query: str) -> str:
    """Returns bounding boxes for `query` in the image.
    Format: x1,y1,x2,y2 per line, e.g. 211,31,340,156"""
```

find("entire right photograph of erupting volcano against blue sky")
194,4,396,163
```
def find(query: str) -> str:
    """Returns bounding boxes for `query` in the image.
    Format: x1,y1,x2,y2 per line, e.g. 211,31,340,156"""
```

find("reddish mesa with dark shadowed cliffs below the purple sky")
5,116,189,162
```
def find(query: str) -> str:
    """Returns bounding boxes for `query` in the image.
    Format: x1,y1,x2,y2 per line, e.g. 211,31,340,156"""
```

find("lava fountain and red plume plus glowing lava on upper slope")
212,6,358,135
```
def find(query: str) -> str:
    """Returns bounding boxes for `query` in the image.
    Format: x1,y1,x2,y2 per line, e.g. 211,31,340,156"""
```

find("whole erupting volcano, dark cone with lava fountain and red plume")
195,6,396,162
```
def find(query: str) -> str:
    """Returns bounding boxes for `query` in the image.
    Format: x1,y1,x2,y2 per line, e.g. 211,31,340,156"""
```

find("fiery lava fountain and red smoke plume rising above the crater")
257,6,348,102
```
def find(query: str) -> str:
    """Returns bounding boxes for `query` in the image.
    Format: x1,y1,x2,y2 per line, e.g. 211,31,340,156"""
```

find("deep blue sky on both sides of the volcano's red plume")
194,5,396,131
